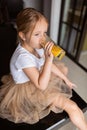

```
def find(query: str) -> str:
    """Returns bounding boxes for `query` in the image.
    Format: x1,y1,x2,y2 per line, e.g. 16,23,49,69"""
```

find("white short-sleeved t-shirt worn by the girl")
10,44,44,84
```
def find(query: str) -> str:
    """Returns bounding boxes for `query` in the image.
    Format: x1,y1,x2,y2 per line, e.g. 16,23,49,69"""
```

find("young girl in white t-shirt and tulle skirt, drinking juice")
0,8,87,130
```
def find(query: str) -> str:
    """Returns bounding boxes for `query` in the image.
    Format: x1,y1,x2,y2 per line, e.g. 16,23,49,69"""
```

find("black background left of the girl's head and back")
0,0,23,85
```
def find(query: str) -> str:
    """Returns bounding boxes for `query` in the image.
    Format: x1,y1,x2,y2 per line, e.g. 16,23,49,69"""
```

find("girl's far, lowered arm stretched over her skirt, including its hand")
52,64,76,89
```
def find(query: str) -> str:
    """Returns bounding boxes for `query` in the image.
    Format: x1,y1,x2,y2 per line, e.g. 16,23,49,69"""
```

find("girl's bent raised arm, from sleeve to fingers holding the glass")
23,42,53,90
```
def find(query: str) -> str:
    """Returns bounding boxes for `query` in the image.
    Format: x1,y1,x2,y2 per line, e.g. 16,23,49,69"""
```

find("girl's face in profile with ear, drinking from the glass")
26,19,48,49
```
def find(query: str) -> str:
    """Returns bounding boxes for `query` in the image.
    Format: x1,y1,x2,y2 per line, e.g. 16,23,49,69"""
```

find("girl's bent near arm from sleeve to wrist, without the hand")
23,59,52,90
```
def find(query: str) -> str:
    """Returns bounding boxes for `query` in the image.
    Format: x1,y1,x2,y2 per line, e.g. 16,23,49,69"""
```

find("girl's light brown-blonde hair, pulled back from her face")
16,8,48,40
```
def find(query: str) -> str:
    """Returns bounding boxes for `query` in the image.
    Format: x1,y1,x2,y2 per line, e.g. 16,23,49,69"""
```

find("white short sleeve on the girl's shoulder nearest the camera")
15,53,36,70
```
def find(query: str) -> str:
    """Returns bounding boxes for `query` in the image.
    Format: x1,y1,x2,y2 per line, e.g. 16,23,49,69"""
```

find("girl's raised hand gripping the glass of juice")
44,42,54,61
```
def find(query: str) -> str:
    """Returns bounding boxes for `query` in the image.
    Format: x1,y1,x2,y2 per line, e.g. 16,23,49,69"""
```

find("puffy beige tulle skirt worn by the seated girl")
0,58,72,124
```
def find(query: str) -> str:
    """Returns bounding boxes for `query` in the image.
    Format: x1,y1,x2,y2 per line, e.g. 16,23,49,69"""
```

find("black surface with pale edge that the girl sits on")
0,91,87,130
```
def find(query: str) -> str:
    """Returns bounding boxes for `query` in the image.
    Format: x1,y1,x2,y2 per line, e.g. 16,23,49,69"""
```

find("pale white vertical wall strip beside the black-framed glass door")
50,0,61,42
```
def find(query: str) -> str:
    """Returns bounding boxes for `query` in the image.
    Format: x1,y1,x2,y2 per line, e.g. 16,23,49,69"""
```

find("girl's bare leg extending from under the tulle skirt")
54,94,87,130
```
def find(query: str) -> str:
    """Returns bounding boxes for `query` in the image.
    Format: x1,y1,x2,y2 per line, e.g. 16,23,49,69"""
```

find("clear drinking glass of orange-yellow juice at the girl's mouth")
41,35,65,60
